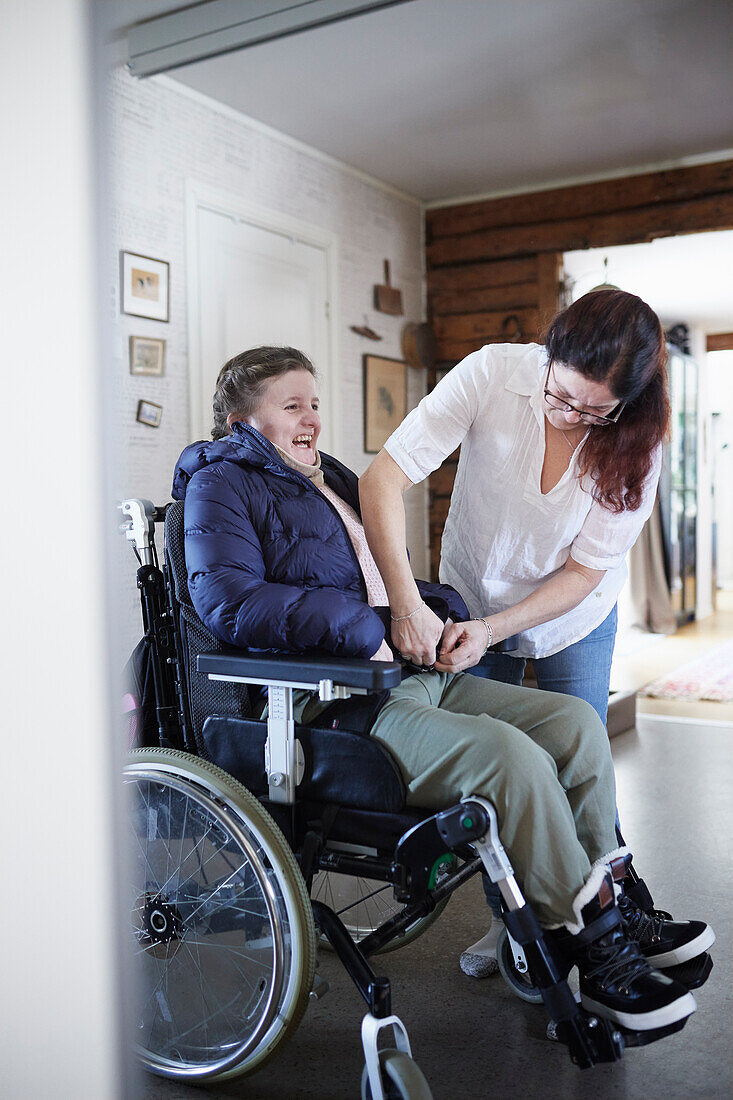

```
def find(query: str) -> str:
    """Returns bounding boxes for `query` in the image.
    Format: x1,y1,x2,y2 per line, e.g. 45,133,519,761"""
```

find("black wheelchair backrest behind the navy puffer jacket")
165,501,252,756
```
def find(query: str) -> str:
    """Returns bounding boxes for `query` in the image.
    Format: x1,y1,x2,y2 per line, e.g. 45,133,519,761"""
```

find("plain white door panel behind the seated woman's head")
190,205,333,451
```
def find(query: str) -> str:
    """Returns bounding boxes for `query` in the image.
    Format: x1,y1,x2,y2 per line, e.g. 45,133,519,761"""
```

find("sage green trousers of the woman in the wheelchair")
371,672,617,925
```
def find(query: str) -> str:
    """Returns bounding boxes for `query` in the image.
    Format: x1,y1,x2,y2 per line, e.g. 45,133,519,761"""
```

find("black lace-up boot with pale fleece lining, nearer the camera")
556,872,696,1031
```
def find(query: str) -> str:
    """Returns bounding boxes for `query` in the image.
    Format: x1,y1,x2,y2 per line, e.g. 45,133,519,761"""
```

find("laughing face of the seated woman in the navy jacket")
238,371,320,466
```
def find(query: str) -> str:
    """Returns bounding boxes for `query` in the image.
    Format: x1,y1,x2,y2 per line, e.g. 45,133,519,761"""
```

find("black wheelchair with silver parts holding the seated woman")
120,499,685,1100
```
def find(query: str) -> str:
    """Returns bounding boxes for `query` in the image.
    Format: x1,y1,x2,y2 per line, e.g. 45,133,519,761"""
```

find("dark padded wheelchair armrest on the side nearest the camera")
196,647,402,692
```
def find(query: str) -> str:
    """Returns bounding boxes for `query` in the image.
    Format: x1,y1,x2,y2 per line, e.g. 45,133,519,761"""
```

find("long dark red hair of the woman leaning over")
545,287,669,513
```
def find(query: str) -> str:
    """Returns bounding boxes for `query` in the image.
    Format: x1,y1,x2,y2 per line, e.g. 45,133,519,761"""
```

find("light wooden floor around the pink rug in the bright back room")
611,591,733,722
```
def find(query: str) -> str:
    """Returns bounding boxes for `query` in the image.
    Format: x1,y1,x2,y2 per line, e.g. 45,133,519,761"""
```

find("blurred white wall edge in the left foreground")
0,0,122,1100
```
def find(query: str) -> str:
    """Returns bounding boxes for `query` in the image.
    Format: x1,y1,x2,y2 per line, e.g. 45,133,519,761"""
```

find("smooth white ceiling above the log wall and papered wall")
113,0,733,201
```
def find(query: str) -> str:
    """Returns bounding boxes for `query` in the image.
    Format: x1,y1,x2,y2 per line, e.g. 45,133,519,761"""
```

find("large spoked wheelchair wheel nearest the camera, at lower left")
124,749,316,1080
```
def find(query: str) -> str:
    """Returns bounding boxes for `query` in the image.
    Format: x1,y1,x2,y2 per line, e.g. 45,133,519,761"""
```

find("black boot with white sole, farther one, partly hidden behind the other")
609,854,715,970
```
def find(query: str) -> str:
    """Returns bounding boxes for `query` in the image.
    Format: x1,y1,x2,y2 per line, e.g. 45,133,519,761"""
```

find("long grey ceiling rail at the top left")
128,0,409,77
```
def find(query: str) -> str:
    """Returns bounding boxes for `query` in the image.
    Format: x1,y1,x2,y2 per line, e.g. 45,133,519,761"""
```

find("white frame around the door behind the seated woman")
185,179,341,453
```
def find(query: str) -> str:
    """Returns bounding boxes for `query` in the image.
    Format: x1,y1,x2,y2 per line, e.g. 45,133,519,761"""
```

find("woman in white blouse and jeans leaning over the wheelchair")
360,287,669,977
